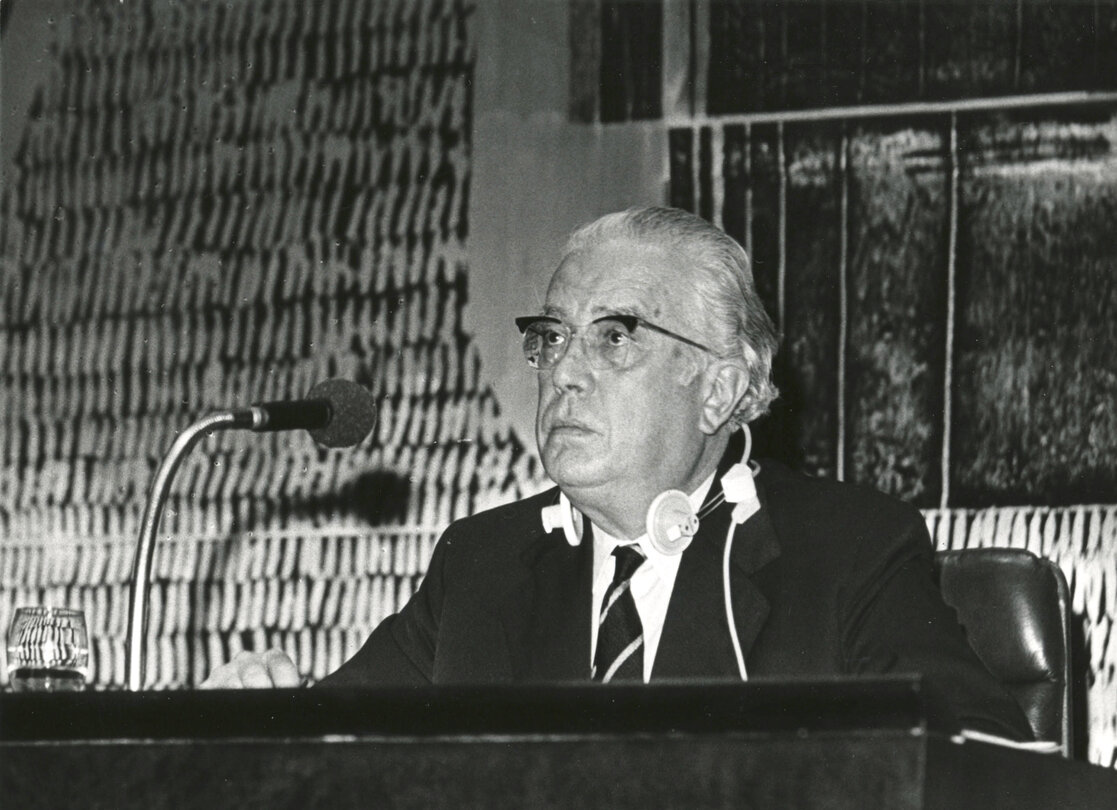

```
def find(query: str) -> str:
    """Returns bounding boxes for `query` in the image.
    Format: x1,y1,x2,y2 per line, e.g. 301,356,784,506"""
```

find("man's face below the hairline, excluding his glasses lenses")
535,233,704,509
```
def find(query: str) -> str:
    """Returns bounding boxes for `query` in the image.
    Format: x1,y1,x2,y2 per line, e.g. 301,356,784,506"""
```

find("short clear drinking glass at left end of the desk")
8,608,89,692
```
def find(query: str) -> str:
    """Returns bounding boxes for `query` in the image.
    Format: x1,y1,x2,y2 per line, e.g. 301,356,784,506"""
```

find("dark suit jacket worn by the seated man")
323,455,1031,738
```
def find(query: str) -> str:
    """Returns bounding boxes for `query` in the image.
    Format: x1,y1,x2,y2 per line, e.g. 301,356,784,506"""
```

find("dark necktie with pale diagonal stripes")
593,545,645,684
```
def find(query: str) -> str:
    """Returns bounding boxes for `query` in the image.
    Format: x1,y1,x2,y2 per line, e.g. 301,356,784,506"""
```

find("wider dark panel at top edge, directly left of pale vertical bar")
601,0,663,122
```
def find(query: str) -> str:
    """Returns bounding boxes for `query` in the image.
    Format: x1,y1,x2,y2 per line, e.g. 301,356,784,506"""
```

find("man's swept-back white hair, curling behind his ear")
563,207,780,425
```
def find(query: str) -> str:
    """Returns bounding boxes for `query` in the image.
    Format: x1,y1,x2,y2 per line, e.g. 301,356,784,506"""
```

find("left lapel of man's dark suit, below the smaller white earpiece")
500,513,593,680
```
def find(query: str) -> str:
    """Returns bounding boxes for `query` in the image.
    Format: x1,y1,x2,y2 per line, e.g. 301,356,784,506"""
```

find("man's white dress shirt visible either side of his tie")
590,473,714,683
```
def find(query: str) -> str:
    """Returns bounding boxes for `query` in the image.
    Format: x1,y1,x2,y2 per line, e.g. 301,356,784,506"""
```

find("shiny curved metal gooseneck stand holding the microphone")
127,410,254,692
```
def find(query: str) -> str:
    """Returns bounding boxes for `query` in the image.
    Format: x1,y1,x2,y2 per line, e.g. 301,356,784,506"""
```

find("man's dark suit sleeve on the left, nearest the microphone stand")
318,530,450,687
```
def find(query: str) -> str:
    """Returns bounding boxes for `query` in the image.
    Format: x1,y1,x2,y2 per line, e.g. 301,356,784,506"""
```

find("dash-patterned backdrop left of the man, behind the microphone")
0,0,541,687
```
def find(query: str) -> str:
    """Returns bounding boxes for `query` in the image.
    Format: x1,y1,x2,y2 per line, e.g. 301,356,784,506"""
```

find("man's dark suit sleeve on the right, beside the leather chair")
843,517,1032,740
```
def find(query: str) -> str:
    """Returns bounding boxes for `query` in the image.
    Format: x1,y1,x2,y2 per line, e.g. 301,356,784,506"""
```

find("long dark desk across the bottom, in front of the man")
0,678,1117,810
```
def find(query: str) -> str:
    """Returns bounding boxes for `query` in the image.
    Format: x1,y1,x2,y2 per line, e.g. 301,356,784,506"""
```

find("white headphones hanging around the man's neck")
540,425,761,555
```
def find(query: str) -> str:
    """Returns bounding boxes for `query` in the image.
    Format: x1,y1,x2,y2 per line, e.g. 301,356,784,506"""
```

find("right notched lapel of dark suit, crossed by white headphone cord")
652,471,780,679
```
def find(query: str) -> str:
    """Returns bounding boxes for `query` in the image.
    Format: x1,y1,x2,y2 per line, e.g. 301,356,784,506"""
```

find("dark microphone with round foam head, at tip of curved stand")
235,379,376,448
